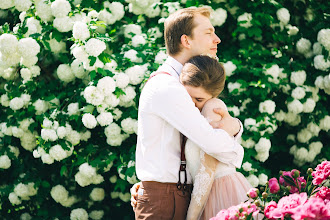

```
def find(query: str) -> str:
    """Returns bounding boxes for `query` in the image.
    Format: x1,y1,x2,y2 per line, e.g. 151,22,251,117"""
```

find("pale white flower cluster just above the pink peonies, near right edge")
290,141,323,166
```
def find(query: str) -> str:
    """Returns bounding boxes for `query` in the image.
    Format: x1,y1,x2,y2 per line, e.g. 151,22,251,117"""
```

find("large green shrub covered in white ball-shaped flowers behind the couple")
0,0,330,219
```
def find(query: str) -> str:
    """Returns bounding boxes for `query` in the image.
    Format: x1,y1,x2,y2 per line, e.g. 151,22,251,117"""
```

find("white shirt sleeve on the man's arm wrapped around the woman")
152,76,244,166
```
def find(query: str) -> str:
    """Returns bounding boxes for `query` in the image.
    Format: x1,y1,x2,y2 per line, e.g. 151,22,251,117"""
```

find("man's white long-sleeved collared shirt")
136,57,244,183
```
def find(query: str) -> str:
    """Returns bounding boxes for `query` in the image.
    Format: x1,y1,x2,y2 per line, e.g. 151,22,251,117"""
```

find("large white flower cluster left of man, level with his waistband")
75,163,104,187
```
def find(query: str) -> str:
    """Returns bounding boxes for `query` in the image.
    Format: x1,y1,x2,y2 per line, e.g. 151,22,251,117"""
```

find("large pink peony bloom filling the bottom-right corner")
291,197,330,220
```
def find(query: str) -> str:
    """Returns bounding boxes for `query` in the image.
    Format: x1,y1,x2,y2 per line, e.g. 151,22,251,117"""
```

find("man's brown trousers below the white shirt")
135,181,192,220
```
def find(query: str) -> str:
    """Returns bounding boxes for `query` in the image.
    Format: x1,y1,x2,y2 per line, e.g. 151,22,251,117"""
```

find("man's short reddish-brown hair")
164,7,210,55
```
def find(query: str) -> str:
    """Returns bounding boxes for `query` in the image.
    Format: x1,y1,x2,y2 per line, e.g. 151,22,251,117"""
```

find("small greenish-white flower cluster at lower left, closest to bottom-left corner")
8,183,38,205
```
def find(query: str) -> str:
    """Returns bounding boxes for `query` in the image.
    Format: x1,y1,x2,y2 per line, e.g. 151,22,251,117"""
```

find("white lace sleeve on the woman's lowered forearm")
191,150,214,206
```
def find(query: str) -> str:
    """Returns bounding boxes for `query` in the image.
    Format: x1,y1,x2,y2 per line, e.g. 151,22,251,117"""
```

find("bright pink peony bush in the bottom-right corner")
217,161,330,220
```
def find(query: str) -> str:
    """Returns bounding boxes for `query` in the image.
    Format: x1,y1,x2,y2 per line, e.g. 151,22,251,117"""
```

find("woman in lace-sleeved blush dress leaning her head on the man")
180,55,252,220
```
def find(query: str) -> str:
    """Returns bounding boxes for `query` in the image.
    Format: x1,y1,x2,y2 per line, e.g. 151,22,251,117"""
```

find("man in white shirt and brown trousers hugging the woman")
131,7,242,220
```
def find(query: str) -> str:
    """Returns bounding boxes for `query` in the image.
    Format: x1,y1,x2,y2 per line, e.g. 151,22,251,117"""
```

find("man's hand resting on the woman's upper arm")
210,108,240,136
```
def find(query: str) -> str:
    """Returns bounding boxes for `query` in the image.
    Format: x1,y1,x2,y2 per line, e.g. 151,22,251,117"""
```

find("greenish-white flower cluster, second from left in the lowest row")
50,185,77,207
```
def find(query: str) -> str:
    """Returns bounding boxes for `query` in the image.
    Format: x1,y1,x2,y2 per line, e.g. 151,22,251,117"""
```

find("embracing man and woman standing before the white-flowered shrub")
131,7,251,220
